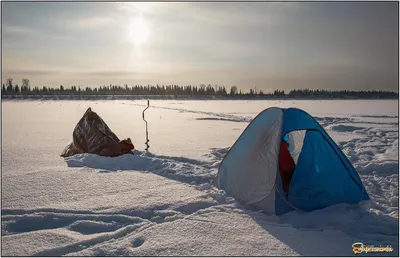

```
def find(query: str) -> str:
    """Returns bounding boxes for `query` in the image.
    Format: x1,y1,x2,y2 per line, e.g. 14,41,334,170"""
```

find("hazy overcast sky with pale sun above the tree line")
1,2,399,91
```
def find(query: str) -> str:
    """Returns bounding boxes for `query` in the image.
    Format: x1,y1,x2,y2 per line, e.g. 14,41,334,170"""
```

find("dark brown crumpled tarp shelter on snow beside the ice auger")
61,108,135,157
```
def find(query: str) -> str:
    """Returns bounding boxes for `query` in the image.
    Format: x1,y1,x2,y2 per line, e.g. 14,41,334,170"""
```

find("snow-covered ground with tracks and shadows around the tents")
1,100,399,256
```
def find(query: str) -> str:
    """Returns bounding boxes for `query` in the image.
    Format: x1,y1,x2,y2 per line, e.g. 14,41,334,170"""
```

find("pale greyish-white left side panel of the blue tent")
217,108,283,212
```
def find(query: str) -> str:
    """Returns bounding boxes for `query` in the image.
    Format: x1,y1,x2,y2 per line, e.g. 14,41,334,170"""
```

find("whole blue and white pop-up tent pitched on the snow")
216,107,369,215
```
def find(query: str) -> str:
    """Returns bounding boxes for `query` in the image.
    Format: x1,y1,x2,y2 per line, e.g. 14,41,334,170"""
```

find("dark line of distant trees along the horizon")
1,78,399,99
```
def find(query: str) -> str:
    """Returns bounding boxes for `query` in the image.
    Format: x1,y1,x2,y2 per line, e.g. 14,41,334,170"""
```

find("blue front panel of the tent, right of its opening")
288,130,365,211
